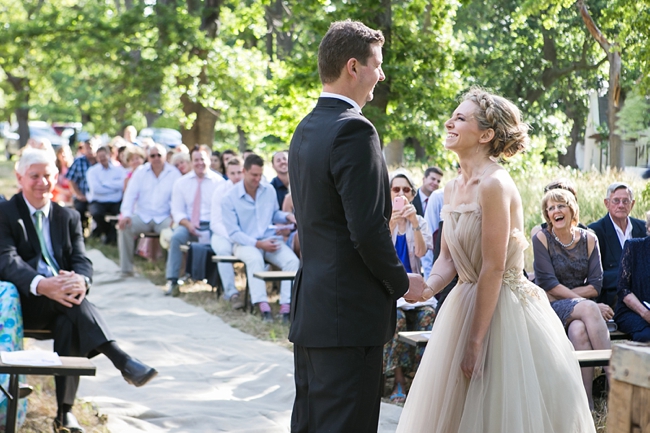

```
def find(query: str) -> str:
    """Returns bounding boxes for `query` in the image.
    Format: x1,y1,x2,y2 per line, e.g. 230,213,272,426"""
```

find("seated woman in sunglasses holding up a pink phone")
384,171,438,403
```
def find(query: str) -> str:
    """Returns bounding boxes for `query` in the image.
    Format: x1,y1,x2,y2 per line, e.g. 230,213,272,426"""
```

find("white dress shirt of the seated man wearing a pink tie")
172,169,225,223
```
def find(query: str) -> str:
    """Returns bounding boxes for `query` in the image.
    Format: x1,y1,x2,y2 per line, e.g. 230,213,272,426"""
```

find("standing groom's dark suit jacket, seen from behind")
289,98,409,347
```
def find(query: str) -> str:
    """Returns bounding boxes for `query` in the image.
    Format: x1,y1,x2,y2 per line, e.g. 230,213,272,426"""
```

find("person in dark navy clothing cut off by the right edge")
614,212,650,341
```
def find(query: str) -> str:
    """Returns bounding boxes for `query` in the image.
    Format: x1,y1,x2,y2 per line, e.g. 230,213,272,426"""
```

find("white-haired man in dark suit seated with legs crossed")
0,149,157,433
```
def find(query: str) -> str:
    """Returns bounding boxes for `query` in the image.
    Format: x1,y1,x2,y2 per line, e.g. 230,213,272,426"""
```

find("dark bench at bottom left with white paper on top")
0,356,96,433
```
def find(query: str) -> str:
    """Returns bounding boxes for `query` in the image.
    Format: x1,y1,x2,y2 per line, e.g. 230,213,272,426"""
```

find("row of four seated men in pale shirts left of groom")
118,146,299,321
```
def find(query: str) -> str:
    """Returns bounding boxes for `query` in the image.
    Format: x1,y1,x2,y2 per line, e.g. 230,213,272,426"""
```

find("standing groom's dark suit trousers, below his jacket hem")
291,345,383,433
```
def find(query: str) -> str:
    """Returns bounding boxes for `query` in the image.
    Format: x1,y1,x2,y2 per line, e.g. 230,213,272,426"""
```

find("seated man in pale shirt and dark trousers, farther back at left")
86,147,126,244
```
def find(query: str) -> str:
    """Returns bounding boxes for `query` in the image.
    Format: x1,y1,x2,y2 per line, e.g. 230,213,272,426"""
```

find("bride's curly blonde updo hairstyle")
463,87,528,158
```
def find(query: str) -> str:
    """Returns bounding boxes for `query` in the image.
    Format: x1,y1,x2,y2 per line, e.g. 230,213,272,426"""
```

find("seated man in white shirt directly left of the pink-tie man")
117,143,181,276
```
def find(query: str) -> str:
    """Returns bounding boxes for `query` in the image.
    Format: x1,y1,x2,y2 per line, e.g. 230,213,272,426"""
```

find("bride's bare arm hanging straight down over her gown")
461,174,517,378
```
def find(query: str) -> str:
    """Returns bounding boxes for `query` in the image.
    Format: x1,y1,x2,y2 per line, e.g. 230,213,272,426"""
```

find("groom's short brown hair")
318,19,384,84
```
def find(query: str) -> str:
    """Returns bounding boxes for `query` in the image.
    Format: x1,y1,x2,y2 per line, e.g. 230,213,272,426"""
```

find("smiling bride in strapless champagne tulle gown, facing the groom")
397,88,595,433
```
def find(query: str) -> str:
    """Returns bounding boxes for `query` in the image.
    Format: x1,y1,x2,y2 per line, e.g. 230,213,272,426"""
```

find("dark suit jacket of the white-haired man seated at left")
0,193,93,299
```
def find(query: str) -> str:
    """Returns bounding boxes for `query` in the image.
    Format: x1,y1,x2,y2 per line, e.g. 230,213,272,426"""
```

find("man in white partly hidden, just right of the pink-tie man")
210,158,244,310
